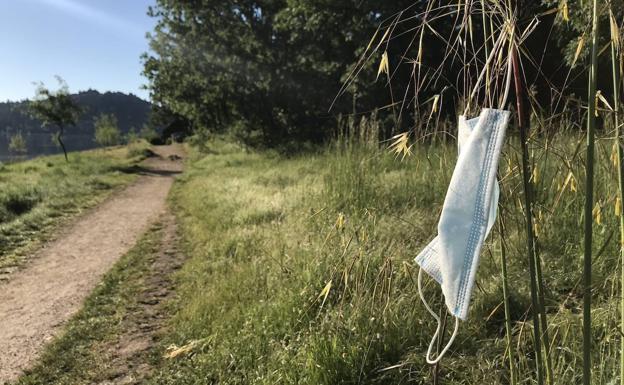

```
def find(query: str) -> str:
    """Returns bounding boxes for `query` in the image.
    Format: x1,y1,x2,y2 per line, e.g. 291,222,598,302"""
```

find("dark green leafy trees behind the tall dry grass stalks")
143,0,623,145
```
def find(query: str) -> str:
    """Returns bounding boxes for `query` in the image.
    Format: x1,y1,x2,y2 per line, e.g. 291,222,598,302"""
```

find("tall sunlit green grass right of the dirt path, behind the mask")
14,133,621,385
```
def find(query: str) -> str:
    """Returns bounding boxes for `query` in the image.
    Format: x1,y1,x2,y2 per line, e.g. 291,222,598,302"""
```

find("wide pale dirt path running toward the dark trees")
0,146,182,384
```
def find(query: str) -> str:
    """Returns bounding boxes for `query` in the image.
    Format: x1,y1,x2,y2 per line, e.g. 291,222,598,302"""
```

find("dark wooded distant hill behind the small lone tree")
0,90,151,160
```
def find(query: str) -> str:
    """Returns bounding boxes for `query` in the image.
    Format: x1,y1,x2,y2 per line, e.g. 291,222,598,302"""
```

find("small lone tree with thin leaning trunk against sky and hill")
28,76,82,162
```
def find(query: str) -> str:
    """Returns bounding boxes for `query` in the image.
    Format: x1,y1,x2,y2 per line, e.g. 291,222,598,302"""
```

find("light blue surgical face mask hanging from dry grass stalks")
416,109,510,363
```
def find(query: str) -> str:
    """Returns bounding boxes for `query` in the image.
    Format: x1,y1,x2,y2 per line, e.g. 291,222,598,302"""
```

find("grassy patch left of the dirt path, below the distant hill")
0,143,147,272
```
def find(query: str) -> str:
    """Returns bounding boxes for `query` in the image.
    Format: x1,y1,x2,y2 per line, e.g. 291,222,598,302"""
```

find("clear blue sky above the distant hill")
0,0,155,101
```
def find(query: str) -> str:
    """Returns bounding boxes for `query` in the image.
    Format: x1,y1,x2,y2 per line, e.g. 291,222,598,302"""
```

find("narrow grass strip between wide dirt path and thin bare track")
17,219,168,385
